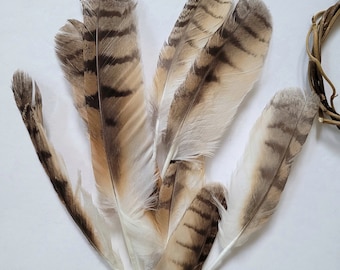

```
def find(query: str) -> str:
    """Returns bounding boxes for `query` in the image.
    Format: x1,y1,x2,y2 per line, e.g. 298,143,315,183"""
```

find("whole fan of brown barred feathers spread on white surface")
12,0,318,270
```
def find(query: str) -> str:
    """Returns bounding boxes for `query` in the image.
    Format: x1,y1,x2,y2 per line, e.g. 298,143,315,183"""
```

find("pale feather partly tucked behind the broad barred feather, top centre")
149,0,232,130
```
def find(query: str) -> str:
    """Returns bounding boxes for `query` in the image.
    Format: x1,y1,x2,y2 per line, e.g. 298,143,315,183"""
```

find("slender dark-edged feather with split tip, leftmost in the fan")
12,71,121,264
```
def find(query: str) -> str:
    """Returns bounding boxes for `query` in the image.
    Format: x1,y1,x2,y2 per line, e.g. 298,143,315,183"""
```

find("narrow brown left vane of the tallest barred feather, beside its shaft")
82,1,115,205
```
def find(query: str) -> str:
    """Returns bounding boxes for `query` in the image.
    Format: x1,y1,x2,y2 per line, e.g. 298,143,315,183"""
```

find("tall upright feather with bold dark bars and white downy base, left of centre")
79,0,158,269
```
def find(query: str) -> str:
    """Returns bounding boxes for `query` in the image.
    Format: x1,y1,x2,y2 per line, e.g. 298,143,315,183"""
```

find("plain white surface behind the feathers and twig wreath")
0,0,340,270
